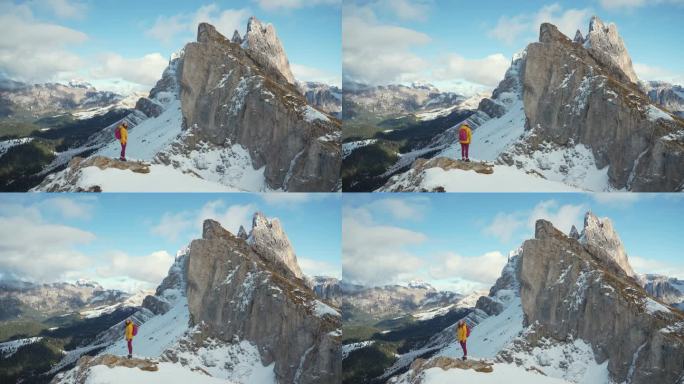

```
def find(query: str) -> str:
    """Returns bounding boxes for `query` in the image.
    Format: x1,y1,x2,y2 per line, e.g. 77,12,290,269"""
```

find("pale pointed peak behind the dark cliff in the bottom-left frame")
247,212,304,279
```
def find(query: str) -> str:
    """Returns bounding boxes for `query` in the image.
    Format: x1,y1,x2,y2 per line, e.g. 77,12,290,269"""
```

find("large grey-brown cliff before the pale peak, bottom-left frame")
187,220,341,383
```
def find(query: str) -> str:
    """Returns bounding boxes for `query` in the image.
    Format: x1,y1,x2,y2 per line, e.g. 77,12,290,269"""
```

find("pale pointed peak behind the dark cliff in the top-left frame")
242,16,295,84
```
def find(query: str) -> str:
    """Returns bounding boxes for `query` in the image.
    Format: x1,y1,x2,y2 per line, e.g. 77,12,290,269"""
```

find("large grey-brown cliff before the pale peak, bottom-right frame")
519,219,684,384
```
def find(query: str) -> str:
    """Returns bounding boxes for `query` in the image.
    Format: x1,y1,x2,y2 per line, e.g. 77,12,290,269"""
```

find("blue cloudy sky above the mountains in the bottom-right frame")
342,193,684,291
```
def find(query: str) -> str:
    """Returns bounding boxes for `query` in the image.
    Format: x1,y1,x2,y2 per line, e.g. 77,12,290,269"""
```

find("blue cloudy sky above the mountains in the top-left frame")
0,0,341,91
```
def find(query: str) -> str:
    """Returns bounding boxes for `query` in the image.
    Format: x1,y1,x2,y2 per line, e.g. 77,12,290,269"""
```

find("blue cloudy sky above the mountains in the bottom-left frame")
0,193,341,290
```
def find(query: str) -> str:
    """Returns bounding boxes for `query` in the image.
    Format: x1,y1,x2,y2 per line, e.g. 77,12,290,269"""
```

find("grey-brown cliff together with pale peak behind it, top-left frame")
174,19,341,192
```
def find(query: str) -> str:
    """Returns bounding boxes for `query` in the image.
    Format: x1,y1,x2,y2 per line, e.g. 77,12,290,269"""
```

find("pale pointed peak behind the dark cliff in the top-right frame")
584,16,639,83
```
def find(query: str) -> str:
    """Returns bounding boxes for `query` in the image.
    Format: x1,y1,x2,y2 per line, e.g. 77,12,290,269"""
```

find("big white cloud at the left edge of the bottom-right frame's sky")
342,207,427,285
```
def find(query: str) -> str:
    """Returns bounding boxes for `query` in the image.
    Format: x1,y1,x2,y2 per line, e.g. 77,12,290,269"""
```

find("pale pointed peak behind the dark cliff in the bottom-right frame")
580,212,634,276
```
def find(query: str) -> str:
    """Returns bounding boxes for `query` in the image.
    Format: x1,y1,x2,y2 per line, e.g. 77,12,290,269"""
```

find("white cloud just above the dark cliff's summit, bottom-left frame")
150,200,256,240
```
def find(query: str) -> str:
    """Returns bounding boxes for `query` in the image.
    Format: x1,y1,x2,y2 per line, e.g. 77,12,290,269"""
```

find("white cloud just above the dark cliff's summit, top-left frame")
145,3,251,44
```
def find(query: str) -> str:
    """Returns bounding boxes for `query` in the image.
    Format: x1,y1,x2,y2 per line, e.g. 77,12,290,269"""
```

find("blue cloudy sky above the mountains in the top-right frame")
343,0,684,92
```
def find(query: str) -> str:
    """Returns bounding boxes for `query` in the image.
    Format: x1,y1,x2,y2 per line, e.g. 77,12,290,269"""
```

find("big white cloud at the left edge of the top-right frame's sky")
342,5,431,84
